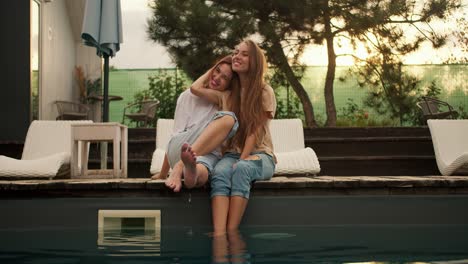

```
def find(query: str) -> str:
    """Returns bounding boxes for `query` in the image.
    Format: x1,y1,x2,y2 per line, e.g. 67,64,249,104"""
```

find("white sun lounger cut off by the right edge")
427,119,468,176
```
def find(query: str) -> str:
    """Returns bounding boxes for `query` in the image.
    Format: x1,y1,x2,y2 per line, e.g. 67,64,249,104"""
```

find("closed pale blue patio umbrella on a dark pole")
81,0,123,122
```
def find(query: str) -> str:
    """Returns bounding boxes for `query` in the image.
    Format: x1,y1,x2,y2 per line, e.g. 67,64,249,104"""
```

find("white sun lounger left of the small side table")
0,120,92,180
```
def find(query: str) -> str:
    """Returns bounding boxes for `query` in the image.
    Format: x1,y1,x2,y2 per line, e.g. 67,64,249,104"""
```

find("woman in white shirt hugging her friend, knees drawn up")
152,56,239,192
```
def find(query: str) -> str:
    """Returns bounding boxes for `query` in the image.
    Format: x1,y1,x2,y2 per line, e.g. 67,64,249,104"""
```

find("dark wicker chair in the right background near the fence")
416,96,458,121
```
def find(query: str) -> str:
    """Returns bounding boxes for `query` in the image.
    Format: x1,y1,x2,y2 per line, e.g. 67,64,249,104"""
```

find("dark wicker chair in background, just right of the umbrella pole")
122,100,159,127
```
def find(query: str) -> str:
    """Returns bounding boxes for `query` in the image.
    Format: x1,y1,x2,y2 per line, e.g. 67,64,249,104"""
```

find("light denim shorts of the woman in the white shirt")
166,111,239,173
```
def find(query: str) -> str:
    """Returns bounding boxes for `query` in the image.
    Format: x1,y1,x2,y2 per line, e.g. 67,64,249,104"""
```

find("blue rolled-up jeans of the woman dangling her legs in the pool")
211,152,275,199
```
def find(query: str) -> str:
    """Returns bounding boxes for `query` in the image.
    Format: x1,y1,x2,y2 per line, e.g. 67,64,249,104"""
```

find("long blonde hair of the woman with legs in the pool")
229,40,267,149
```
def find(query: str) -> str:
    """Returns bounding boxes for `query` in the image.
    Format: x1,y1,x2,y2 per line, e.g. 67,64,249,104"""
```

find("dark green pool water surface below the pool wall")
0,225,468,263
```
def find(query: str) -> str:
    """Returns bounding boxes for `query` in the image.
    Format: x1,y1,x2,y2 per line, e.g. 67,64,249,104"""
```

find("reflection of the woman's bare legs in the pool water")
212,231,251,263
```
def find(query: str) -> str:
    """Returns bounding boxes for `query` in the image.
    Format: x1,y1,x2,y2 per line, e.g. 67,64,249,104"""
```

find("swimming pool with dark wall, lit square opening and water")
0,194,468,263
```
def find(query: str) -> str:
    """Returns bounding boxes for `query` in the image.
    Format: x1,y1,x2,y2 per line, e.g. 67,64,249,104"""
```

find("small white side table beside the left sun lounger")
71,123,128,178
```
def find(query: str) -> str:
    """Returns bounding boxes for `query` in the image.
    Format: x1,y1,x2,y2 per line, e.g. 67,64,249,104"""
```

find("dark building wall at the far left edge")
0,0,31,141
